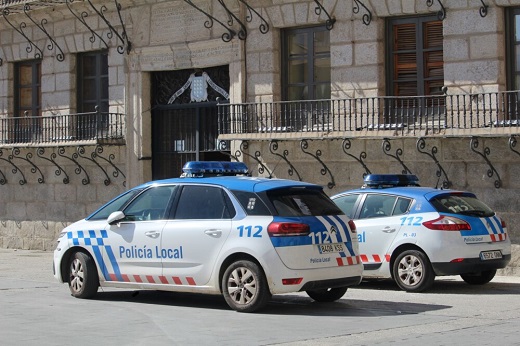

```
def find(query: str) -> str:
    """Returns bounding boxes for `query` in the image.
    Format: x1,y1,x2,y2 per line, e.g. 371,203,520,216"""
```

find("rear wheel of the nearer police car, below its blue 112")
221,260,271,312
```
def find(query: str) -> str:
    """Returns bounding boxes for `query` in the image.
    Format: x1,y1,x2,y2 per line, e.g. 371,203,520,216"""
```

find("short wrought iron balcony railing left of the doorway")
0,112,125,145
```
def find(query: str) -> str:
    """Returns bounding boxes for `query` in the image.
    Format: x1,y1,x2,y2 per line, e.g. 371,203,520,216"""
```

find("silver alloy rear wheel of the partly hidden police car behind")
392,250,435,292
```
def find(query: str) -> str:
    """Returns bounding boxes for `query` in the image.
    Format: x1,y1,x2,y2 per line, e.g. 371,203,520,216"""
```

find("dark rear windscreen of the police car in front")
267,189,343,217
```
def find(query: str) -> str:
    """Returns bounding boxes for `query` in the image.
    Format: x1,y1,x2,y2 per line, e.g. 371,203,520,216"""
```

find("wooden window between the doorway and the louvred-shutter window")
282,26,330,101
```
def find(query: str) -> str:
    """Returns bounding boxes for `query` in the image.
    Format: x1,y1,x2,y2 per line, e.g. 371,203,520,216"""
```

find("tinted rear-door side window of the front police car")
174,185,235,220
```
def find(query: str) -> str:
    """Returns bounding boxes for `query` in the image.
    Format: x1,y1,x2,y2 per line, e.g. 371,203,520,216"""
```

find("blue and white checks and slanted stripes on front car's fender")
67,230,123,281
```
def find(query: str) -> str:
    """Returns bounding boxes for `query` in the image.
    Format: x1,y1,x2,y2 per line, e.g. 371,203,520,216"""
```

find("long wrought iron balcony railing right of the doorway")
219,91,520,135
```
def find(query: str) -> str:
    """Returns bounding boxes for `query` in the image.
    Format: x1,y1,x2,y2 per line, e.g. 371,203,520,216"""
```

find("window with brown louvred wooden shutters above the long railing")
387,16,444,96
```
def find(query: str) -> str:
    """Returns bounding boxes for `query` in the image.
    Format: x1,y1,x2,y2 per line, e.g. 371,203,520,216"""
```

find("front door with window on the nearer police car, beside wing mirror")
102,186,175,284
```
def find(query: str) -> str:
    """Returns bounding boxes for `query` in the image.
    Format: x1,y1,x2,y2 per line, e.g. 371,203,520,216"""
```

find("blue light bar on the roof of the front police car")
182,161,249,177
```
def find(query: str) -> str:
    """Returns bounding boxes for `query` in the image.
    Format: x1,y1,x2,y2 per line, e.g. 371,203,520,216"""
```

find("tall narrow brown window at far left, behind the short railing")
13,60,42,143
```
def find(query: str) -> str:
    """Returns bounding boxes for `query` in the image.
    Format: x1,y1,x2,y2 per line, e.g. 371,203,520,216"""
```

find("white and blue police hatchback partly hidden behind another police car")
331,174,511,292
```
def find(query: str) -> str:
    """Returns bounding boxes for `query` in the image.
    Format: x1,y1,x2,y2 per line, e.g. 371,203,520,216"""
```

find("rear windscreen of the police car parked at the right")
431,194,495,217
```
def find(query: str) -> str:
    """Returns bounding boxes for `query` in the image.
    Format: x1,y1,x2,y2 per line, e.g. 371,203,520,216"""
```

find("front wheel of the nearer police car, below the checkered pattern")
68,252,99,299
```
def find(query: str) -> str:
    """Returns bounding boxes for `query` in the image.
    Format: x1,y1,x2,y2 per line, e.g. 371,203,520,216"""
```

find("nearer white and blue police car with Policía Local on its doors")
54,161,363,312
